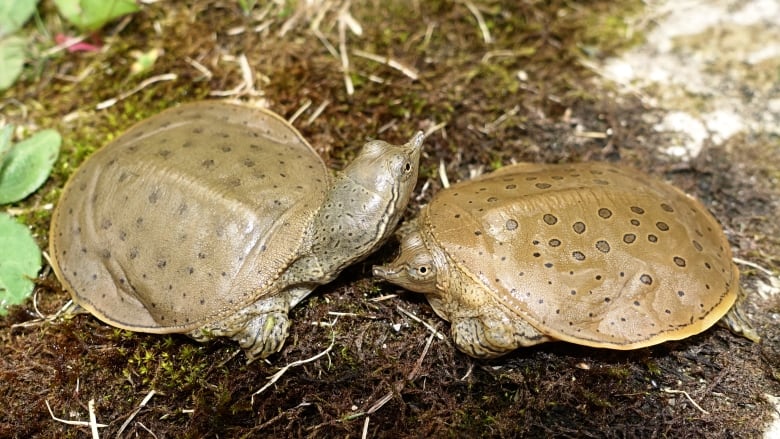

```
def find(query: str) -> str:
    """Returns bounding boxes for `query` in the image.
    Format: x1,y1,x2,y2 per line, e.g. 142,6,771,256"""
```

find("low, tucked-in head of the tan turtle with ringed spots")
374,225,437,294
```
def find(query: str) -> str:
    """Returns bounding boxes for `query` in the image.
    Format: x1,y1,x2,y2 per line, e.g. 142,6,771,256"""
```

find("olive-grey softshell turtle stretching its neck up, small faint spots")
50,101,423,360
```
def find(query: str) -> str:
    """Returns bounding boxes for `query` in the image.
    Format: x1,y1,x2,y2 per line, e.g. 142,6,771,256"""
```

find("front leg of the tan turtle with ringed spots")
450,306,551,359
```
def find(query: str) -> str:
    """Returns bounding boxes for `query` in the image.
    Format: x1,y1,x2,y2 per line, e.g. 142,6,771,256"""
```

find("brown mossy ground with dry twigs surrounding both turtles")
0,0,780,438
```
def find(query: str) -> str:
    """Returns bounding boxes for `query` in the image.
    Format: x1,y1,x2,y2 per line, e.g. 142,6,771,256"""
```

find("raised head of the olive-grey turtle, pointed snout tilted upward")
343,131,425,227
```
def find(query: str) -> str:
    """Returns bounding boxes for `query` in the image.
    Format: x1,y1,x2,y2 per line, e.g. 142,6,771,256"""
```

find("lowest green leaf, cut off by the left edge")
0,213,41,315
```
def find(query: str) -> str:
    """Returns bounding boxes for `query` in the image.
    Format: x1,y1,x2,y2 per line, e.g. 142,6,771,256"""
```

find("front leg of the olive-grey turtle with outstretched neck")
188,287,311,363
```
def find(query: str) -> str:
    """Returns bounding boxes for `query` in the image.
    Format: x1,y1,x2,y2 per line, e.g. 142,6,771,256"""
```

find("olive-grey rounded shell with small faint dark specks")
50,102,330,333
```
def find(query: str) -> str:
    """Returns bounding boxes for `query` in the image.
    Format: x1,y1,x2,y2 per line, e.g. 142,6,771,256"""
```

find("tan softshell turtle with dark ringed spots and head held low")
374,163,760,358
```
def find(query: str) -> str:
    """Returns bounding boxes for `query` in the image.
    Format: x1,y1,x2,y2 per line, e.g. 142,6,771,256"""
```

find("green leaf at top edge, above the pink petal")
54,0,138,32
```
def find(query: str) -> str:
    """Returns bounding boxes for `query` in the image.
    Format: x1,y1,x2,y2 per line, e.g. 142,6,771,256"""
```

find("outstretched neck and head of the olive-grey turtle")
280,133,423,288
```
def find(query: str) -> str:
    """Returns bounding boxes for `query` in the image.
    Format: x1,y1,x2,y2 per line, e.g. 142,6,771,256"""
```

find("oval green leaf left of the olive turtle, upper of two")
0,130,62,204
